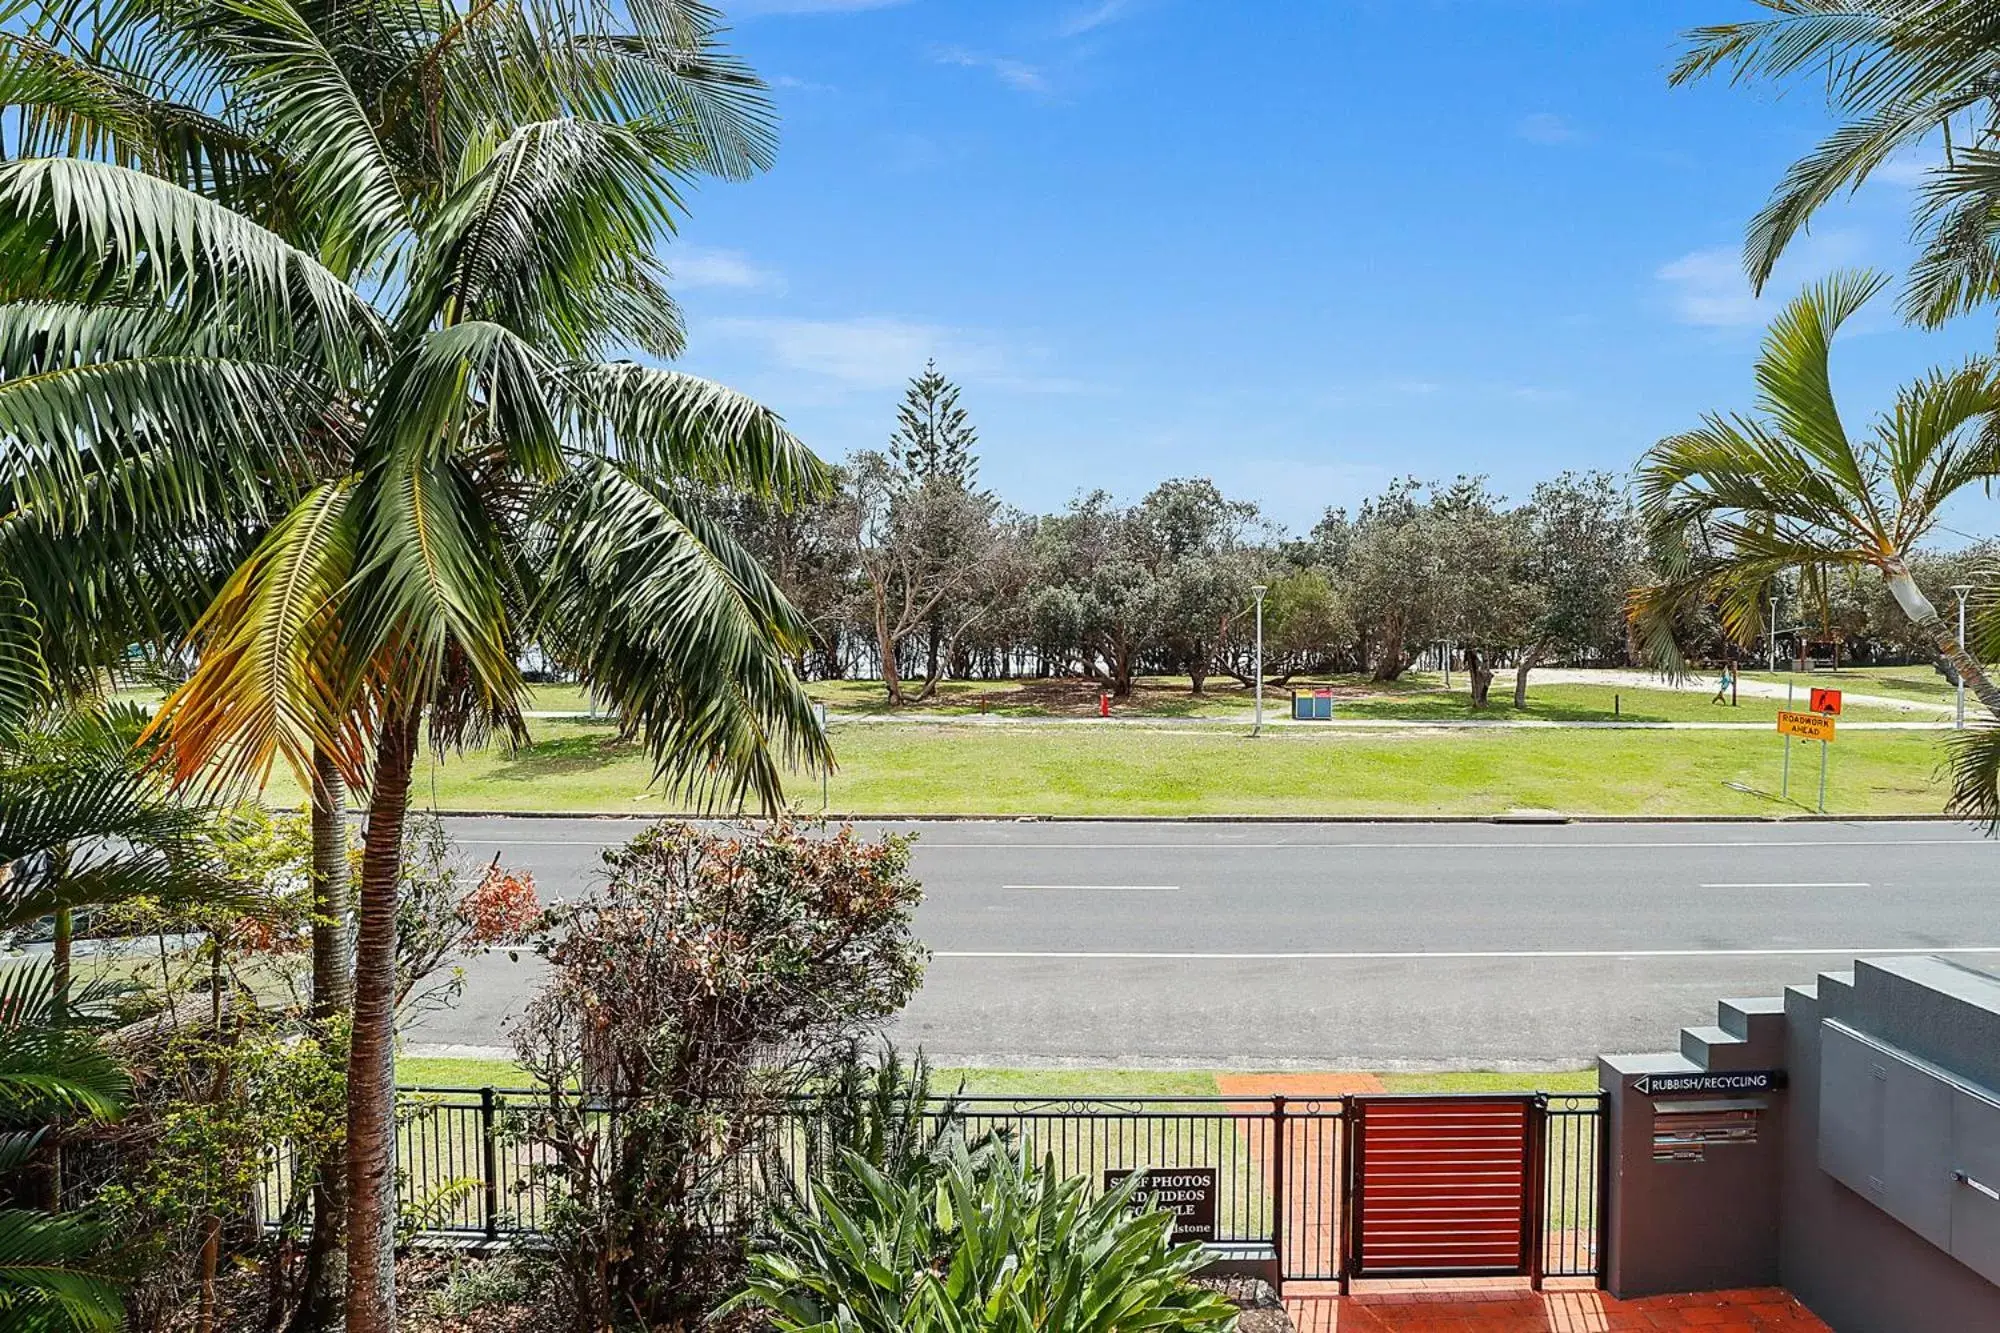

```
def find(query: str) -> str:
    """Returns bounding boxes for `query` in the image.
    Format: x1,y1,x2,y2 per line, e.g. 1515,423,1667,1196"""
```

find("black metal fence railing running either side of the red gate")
260,1087,1606,1281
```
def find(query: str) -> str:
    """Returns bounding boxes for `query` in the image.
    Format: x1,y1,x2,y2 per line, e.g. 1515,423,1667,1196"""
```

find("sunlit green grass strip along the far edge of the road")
282,711,1946,817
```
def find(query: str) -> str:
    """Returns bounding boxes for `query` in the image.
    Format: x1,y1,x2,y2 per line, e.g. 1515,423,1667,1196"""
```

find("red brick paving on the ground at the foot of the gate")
1284,1283,1828,1333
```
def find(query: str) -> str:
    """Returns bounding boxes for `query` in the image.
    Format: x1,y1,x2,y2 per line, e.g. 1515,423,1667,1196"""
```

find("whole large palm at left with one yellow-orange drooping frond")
0,0,828,1329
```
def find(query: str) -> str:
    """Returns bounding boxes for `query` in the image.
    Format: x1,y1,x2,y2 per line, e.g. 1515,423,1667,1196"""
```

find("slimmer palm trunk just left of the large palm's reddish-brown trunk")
292,751,354,1333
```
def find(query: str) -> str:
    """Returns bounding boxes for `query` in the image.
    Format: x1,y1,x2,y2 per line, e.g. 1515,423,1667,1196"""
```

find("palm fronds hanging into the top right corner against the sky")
1672,0,2000,324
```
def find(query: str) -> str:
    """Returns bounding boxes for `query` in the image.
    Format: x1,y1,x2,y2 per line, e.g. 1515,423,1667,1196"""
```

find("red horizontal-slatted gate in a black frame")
1346,1097,1542,1277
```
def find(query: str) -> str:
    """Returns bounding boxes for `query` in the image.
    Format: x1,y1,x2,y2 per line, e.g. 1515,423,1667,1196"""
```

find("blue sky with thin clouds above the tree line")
668,0,1992,530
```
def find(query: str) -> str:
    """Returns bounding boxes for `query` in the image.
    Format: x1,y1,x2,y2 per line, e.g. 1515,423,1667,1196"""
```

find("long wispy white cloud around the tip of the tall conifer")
700,314,1082,392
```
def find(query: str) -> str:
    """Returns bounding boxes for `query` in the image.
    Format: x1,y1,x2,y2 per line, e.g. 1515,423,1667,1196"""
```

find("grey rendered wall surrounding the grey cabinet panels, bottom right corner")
1778,959,2000,1333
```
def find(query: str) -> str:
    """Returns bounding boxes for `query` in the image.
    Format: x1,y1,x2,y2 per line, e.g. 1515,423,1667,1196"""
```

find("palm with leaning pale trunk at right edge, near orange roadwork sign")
1632,272,2000,819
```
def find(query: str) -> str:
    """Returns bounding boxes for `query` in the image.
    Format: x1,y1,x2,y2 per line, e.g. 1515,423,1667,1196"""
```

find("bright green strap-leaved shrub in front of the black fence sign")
724,1143,1236,1333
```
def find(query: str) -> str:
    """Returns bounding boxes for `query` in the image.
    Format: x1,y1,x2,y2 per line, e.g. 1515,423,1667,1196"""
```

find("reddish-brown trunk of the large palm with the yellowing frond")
348,703,420,1333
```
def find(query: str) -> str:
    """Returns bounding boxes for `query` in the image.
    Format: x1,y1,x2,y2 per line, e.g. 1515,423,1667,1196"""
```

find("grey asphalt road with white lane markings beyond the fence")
410,819,2000,1069
